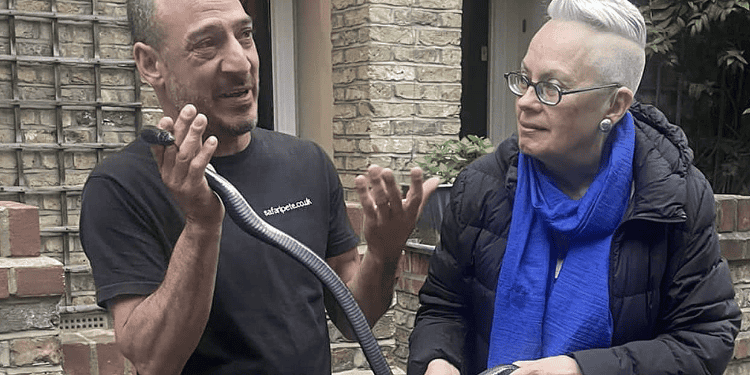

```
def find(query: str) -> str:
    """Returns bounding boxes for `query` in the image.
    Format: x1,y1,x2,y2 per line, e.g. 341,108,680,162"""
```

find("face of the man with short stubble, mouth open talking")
156,0,259,136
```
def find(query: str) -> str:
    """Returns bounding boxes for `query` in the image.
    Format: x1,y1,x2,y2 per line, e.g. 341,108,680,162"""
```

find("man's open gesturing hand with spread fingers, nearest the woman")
355,165,440,261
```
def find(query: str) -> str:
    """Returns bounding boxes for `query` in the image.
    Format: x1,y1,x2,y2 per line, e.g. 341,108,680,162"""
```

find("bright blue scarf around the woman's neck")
487,113,635,368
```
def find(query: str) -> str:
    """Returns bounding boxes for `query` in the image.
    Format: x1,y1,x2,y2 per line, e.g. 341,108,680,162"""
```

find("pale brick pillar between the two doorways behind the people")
331,0,462,200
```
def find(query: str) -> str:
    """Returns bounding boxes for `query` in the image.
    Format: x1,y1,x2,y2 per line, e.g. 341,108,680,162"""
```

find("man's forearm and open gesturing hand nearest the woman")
327,165,439,338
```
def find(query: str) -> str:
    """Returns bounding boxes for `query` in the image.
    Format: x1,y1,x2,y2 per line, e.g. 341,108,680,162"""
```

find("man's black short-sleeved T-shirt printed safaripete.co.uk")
81,129,358,374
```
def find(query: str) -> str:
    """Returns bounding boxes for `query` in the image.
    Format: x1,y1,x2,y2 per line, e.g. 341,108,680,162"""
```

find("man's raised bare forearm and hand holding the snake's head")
110,105,224,375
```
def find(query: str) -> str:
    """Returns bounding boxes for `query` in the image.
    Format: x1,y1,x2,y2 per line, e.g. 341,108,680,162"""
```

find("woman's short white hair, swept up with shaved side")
547,0,646,93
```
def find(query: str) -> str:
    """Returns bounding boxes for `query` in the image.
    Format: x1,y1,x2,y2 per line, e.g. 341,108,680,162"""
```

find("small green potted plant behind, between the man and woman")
417,134,495,183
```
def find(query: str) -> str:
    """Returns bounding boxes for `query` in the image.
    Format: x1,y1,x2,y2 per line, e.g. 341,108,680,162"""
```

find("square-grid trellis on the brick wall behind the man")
0,0,156,318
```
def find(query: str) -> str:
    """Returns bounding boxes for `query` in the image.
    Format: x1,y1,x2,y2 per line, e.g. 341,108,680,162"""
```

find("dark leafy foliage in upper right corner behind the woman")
640,0,750,194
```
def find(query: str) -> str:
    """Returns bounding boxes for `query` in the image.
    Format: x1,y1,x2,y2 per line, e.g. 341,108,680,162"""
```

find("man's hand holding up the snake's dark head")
151,104,224,224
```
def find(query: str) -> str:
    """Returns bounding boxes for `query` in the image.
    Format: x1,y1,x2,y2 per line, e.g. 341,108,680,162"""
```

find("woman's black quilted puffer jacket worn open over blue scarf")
408,104,740,375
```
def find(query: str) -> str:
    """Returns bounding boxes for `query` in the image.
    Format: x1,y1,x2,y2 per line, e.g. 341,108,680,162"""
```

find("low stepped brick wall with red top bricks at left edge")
0,201,64,375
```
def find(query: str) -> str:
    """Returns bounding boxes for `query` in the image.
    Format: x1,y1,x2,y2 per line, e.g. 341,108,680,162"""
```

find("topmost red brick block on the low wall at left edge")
0,201,41,257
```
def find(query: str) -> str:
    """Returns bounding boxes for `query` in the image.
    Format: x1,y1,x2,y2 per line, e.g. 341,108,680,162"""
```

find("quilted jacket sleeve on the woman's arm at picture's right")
572,167,741,375
